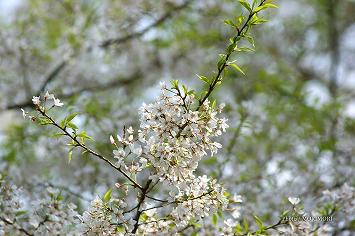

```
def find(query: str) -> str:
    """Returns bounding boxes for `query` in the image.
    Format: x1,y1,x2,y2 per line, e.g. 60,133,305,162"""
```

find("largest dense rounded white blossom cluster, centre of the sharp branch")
138,84,228,183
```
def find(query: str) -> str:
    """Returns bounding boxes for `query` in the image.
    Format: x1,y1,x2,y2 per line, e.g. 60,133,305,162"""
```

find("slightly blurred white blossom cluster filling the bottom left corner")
0,178,78,235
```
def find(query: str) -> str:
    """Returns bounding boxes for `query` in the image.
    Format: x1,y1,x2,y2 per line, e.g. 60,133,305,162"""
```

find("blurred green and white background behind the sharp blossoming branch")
0,0,355,233
